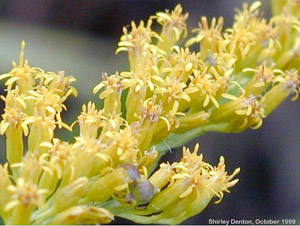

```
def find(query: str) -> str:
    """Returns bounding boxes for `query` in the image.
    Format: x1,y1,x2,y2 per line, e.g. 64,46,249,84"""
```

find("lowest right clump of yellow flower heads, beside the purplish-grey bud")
120,144,240,224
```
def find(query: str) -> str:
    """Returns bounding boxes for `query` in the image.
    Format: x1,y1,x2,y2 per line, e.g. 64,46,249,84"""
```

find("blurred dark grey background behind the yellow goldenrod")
0,0,300,224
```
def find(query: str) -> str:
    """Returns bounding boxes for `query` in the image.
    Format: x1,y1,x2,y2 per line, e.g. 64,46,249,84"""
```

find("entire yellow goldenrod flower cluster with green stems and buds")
0,0,300,225
